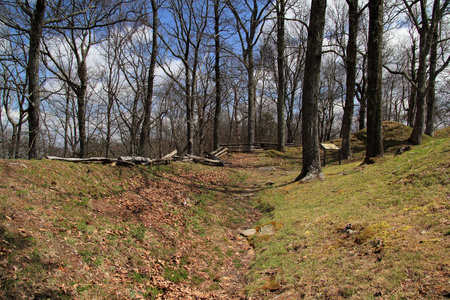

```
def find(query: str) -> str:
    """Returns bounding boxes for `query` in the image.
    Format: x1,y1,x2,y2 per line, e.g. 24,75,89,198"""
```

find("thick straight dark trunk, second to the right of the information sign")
365,0,384,162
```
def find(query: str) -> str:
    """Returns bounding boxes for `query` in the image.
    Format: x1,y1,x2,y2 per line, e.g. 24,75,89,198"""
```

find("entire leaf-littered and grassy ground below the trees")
0,123,450,299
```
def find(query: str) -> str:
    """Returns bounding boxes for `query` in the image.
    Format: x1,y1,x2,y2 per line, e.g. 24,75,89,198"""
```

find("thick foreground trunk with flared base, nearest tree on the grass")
295,0,327,181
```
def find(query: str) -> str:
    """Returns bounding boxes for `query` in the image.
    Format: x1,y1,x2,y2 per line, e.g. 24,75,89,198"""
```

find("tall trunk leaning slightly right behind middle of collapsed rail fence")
138,0,159,156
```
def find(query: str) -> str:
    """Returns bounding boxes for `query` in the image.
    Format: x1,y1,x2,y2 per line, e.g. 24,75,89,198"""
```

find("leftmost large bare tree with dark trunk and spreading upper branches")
0,0,137,158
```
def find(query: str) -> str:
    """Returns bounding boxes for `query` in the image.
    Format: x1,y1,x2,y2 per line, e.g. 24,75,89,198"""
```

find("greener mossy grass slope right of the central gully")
249,124,450,299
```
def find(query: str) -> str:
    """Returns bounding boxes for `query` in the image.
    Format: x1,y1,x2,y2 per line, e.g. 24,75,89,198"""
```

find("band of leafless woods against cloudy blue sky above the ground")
0,0,450,158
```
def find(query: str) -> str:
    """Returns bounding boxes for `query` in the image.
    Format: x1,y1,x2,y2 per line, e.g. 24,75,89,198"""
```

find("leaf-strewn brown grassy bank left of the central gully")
0,160,254,299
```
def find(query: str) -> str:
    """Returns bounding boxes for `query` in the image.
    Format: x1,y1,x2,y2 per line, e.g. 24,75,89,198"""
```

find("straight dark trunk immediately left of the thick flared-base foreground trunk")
277,0,286,152
